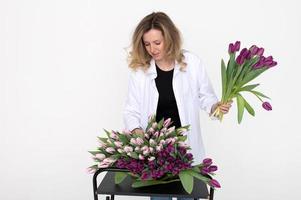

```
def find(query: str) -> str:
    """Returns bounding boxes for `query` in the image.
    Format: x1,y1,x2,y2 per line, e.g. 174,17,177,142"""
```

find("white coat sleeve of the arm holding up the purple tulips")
196,59,218,113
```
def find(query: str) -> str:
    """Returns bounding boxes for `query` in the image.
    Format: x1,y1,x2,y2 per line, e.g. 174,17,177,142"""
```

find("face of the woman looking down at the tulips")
143,29,165,61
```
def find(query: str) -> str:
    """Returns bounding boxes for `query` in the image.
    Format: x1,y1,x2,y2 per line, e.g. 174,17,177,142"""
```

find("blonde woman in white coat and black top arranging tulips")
123,12,231,200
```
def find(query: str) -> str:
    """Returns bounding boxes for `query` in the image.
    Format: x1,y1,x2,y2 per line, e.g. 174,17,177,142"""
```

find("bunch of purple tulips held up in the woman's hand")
212,41,277,123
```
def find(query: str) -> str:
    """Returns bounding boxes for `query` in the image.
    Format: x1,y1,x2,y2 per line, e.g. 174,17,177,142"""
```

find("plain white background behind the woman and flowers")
0,0,301,200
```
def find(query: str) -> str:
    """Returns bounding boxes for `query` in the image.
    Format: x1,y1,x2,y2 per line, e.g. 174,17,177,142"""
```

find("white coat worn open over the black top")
123,51,218,164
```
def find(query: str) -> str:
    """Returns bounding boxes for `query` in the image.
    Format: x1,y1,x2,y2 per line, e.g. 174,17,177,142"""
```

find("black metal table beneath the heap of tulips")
93,168,214,200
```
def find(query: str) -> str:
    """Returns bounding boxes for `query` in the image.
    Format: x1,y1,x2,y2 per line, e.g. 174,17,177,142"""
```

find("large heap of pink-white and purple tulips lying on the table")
88,116,220,193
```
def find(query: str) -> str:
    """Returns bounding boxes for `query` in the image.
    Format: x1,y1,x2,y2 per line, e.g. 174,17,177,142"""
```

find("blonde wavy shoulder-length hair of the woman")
128,12,187,70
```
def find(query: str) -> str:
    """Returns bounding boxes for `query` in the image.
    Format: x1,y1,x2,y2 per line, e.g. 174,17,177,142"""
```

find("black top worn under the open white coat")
155,65,181,128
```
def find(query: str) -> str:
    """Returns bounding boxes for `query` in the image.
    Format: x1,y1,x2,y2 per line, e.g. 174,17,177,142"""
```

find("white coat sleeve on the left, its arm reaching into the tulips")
123,71,141,131
